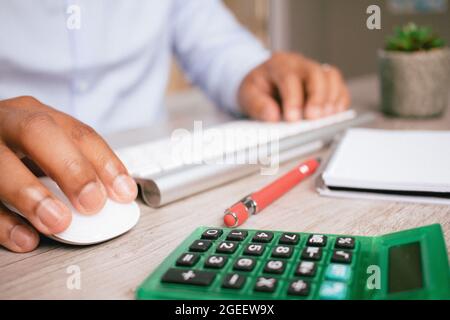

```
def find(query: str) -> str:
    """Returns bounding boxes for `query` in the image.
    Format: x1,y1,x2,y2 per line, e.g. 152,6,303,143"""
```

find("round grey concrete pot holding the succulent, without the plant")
378,48,450,118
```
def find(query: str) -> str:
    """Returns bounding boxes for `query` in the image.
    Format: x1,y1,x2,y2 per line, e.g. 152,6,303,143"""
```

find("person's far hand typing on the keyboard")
238,53,350,121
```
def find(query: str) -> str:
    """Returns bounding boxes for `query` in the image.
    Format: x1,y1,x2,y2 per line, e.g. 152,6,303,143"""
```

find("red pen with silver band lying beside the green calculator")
223,159,320,228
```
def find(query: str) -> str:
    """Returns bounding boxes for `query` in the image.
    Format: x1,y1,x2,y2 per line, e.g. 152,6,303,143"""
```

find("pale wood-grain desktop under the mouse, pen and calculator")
0,77,450,299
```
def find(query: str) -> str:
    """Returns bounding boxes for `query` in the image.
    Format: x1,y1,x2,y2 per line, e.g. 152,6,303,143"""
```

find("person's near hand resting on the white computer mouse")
0,97,137,252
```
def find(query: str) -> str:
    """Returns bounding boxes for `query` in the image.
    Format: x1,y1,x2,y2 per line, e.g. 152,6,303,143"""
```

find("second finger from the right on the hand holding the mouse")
4,110,106,214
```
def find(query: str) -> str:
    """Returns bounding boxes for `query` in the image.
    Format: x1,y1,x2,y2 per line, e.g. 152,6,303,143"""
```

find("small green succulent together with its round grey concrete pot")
379,23,450,117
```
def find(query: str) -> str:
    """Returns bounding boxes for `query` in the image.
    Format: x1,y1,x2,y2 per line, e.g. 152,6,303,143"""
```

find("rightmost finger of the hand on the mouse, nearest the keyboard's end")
62,120,138,203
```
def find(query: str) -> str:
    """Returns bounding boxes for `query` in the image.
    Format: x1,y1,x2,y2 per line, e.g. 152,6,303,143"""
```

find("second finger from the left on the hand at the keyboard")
268,71,304,121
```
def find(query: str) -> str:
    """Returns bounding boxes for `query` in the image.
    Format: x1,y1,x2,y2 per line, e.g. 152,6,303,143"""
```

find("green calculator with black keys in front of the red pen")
136,224,450,300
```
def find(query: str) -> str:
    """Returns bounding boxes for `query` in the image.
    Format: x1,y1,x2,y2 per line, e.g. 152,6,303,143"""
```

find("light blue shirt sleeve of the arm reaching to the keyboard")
171,0,270,113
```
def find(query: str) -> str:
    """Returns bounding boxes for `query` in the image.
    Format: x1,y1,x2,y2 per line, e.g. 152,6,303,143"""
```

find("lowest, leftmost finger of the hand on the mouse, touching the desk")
0,204,39,252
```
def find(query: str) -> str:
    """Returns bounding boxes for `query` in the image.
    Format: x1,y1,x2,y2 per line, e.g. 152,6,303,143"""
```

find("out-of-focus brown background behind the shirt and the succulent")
168,0,450,93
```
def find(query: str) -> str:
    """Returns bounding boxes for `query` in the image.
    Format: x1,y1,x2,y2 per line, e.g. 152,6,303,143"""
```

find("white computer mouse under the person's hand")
6,177,140,246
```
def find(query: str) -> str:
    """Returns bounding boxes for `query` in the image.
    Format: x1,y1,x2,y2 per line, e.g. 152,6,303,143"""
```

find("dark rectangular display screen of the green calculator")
388,242,423,293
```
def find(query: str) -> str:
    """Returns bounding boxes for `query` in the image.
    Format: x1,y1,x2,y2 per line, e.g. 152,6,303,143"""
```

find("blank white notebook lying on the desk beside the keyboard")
318,129,450,204
